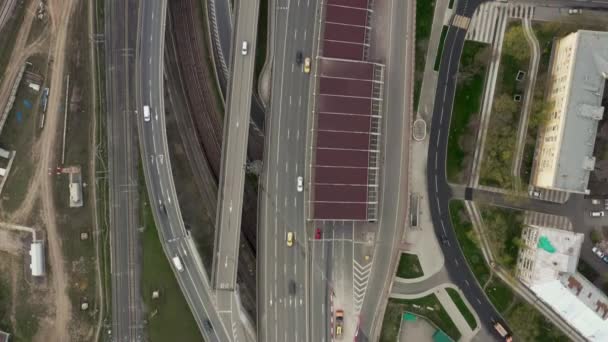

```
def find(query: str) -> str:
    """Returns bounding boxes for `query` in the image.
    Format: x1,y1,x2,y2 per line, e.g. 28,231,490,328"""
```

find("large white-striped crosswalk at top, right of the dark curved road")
467,2,534,44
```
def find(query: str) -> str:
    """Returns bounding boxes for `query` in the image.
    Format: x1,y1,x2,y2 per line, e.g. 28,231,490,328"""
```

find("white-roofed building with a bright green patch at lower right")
517,226,608,342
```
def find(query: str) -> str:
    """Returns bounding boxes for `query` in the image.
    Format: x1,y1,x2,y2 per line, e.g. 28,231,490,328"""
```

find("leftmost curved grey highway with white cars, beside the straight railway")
136,0,233,341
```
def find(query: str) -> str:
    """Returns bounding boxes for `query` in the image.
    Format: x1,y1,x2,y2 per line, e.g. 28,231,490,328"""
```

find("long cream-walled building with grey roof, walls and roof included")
531,30,608,193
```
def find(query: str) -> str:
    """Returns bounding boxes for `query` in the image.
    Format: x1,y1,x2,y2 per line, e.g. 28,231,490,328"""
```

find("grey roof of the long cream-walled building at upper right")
554,30,608,192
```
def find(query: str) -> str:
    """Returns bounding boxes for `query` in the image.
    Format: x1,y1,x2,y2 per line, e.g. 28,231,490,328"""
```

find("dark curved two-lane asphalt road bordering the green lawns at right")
427,0,507,338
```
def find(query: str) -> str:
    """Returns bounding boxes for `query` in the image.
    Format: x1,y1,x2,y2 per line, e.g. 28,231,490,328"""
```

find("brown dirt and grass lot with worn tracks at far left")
0,0,98,342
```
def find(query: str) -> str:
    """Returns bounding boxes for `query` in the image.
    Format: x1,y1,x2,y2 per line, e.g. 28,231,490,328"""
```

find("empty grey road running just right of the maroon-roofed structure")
357,0,415,341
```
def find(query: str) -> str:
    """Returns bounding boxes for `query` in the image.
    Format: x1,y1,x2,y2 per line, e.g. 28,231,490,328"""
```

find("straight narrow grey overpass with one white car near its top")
212,0,259,292
